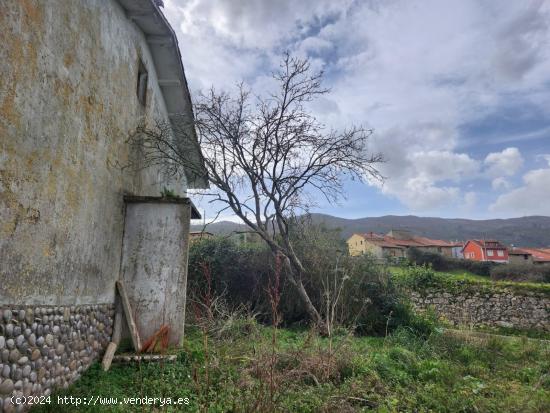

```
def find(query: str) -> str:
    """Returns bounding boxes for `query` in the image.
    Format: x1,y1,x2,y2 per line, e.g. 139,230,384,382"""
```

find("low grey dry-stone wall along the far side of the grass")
409,287,550,331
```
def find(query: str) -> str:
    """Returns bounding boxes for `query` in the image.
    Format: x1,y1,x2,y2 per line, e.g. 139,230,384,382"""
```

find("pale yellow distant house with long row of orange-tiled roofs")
347,230,456,258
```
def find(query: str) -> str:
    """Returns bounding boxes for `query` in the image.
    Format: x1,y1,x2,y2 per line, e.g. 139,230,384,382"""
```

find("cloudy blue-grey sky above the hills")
164,0,550,218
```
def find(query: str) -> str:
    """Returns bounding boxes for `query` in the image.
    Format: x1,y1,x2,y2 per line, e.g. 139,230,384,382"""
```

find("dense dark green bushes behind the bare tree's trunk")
188,226,436,335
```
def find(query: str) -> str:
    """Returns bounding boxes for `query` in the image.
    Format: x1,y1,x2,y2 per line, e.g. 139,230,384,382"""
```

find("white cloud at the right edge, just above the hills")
489,169,550,216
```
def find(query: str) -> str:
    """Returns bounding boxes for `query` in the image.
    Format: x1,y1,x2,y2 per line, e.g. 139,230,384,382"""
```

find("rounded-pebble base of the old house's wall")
0,304,115,412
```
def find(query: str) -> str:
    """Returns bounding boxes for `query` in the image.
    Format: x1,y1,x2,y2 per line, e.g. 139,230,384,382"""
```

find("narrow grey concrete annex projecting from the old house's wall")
122,200,191,345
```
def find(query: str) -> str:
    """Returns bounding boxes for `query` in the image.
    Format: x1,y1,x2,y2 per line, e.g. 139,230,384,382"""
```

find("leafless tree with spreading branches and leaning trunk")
130,54,383,331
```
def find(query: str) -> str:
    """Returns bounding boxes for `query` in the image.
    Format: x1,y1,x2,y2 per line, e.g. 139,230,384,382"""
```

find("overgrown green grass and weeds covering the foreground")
33,319,550,413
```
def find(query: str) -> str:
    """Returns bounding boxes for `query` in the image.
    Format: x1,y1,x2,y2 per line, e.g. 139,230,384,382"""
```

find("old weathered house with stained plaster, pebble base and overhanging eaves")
0,0,207,411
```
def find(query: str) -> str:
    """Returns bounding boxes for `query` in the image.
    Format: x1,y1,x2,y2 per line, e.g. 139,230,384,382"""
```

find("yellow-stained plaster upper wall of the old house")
0,0,185,305
